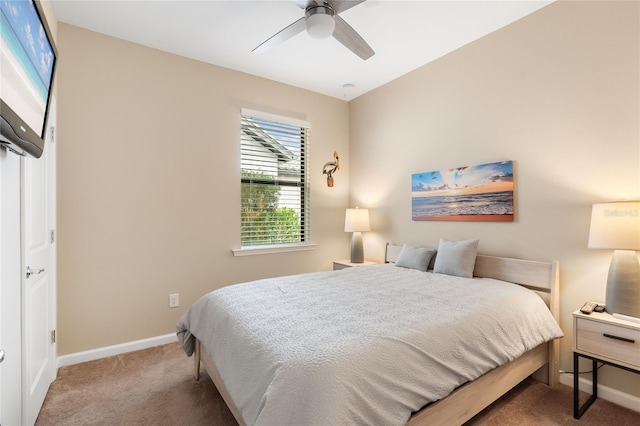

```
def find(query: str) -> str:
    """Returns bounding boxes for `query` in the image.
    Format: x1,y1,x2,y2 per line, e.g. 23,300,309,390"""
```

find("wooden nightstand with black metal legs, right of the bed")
573,310,640,419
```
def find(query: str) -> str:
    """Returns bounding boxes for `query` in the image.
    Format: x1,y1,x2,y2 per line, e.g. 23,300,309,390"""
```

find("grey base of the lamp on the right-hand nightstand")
605,250,640,318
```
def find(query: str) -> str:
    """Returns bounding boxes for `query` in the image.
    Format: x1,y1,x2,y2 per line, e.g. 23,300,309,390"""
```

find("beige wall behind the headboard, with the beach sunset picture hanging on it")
350,2,640,396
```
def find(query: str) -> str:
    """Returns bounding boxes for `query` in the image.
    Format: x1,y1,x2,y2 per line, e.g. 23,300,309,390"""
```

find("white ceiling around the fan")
52,0,552,100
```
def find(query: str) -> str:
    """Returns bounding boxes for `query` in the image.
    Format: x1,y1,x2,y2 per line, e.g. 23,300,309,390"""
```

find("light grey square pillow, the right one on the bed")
433,238,479,278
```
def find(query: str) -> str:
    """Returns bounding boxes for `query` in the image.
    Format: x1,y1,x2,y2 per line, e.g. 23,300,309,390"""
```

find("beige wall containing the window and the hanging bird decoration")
58,23,349,355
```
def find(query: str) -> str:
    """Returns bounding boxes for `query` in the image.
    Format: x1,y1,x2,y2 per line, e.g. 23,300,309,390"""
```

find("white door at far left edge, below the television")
0,149,22,426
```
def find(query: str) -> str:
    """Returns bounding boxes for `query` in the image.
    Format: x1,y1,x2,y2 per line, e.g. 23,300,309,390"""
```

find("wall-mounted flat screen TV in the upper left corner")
0,0,57,158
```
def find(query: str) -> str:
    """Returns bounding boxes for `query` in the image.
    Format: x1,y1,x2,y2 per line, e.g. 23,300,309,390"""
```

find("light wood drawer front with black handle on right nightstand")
576,318,640,368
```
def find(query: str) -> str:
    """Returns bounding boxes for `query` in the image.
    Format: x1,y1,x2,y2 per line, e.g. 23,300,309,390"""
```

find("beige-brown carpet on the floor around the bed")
36,343,640,426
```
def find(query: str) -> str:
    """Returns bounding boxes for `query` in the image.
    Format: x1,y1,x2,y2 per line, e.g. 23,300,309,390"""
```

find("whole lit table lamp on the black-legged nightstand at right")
589,201,640,318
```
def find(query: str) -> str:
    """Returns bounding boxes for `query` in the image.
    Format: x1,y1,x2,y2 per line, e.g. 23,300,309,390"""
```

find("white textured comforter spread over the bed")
177,265,562,426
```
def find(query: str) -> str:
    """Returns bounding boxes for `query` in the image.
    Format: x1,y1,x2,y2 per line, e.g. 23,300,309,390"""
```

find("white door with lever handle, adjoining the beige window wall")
22,100,56,425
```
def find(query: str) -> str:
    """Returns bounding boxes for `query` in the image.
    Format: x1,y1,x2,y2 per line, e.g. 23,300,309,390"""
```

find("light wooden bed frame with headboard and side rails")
194,244,559,426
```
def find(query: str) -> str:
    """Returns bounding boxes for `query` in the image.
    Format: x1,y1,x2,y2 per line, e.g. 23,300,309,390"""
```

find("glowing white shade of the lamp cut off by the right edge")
589,201,640,250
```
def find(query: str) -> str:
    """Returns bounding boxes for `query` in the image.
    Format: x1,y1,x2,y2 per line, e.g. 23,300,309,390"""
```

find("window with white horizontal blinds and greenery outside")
240,110,309,248
